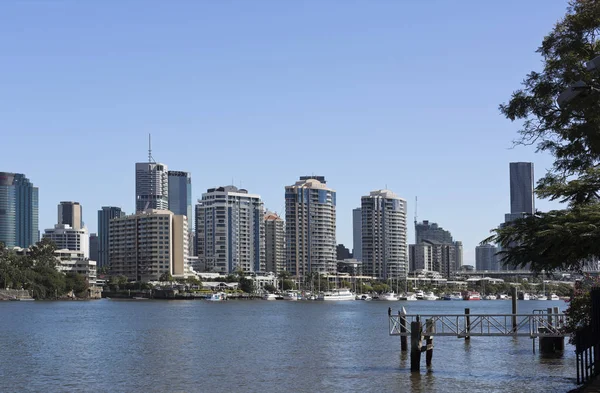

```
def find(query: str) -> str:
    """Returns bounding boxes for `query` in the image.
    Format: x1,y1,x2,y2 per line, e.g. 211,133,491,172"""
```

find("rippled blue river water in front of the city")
0,299,575,393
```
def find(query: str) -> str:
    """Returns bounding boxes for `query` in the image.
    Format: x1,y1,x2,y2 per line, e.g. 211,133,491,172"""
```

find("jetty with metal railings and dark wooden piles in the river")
389,307,566,371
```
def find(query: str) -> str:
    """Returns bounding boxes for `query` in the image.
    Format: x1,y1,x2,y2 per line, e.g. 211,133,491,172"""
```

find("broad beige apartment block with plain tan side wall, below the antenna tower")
109,209,188,281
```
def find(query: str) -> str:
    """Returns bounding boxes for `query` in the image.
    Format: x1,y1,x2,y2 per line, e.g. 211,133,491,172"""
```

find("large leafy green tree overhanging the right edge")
482,0,600,272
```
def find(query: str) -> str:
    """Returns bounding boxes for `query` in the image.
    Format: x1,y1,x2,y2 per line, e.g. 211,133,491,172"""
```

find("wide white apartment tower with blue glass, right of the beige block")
196,186,265,273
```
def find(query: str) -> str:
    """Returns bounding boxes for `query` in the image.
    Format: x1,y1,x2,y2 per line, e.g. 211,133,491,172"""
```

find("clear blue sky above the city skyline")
0,0,567,263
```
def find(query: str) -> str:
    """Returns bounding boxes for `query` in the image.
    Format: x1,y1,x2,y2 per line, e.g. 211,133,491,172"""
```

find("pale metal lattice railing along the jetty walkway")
389,313,566,338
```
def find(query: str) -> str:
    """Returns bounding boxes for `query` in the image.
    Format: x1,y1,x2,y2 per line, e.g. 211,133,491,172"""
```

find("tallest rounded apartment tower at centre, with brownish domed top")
285,178,337,277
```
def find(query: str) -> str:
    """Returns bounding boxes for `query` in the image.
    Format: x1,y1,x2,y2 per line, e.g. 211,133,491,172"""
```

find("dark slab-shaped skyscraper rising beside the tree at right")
510,162,535,214
